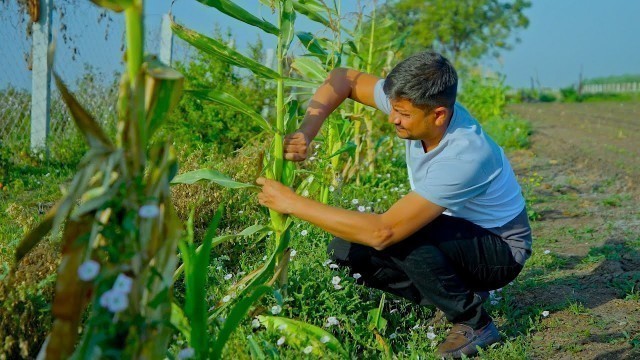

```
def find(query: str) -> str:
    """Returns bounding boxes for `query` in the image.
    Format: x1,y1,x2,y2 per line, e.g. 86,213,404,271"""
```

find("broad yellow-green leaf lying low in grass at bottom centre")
258,315,348,357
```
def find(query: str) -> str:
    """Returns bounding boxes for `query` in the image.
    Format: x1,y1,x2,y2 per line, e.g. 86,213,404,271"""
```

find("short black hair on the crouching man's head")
383,51,458,109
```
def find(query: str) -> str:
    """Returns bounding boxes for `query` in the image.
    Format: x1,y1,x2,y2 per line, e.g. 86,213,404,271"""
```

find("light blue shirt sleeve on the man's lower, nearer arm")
415,158,501,211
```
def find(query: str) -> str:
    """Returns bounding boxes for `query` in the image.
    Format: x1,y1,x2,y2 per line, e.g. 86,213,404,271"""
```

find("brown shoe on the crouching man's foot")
437,321,500,359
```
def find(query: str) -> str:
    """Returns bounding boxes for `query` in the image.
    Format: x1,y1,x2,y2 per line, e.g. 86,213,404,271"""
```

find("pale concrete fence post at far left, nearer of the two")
31,0,52,152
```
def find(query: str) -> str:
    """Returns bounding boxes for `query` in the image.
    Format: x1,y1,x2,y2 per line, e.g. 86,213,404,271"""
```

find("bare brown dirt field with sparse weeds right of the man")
509,103,640,359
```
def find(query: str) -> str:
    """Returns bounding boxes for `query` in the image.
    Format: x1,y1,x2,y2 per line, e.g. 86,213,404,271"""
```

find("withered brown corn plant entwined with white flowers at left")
11,0,183,359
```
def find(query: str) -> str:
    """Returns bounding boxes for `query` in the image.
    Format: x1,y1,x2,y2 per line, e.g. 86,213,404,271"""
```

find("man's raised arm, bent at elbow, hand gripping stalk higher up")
284,68,380,161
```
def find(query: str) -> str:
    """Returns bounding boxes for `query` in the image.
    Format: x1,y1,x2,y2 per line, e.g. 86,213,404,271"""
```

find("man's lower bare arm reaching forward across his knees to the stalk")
256,178,445,250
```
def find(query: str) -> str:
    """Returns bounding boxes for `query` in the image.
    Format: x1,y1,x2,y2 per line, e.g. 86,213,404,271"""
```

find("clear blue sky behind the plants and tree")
0,0,640,89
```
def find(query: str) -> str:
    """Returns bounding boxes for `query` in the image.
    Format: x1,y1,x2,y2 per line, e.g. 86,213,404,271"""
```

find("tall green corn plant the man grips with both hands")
166,0,341,358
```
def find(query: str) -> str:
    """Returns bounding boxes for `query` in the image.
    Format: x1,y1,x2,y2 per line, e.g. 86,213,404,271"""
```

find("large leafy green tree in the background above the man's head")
385,0,531,66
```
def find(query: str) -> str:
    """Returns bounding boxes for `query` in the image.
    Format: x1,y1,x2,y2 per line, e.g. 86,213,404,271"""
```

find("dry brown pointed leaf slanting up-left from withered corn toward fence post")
53,72,113,149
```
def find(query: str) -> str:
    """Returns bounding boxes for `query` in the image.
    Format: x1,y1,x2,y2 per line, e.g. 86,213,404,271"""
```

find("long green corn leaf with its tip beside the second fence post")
171,21,280,80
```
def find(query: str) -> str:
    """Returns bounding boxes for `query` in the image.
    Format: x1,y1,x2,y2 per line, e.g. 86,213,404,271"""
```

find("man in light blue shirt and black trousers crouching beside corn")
257,52,531,357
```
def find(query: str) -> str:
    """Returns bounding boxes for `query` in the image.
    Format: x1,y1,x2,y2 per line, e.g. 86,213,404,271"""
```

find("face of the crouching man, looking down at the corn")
389,99,435,140
